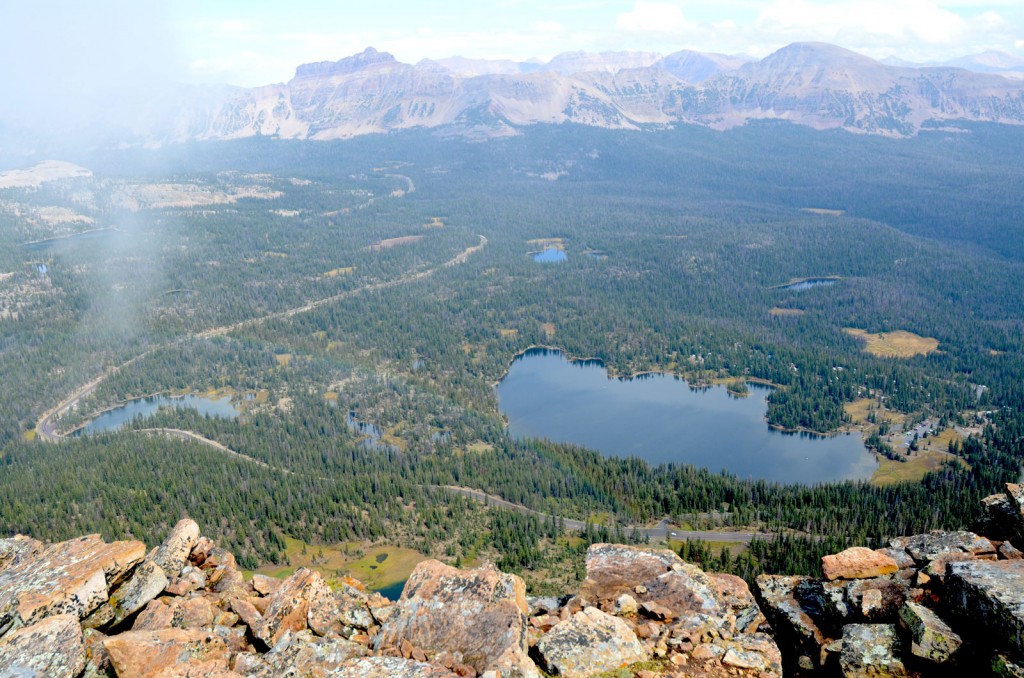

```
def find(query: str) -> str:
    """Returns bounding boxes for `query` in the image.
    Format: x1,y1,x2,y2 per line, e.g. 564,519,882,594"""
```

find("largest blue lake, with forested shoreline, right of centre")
498,348,878,484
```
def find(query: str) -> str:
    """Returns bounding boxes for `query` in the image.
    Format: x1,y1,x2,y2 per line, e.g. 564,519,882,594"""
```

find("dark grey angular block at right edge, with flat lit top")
946,560,1024,652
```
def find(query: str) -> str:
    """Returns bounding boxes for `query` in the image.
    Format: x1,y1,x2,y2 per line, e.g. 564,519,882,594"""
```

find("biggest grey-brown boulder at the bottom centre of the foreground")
374,560,539,677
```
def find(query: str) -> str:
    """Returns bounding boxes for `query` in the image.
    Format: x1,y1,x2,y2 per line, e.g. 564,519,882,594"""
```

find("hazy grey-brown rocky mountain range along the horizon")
12,43,1024,144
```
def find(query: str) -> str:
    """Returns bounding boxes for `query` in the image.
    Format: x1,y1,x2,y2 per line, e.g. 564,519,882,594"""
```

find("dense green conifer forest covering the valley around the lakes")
0,123,1024,589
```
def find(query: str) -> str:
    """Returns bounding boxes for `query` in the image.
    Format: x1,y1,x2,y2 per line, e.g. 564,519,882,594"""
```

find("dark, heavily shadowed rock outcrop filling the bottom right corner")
756,484,1024,677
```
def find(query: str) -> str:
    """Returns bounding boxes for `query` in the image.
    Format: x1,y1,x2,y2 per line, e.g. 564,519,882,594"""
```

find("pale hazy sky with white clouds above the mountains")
0,0,1024,91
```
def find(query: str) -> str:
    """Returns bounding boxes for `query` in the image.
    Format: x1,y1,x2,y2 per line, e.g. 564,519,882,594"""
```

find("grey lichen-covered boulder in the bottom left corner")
0,615,85,678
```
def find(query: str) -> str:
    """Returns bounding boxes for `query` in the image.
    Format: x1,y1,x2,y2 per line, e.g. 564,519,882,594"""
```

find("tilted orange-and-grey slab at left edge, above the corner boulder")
0,535,145,634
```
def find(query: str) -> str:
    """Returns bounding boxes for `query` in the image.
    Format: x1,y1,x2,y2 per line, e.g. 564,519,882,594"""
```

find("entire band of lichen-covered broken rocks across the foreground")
0,485,1024,678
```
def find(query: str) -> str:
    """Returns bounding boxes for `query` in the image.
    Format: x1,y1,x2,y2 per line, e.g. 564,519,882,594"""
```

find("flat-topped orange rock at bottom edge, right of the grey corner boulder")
103,629,229,678
